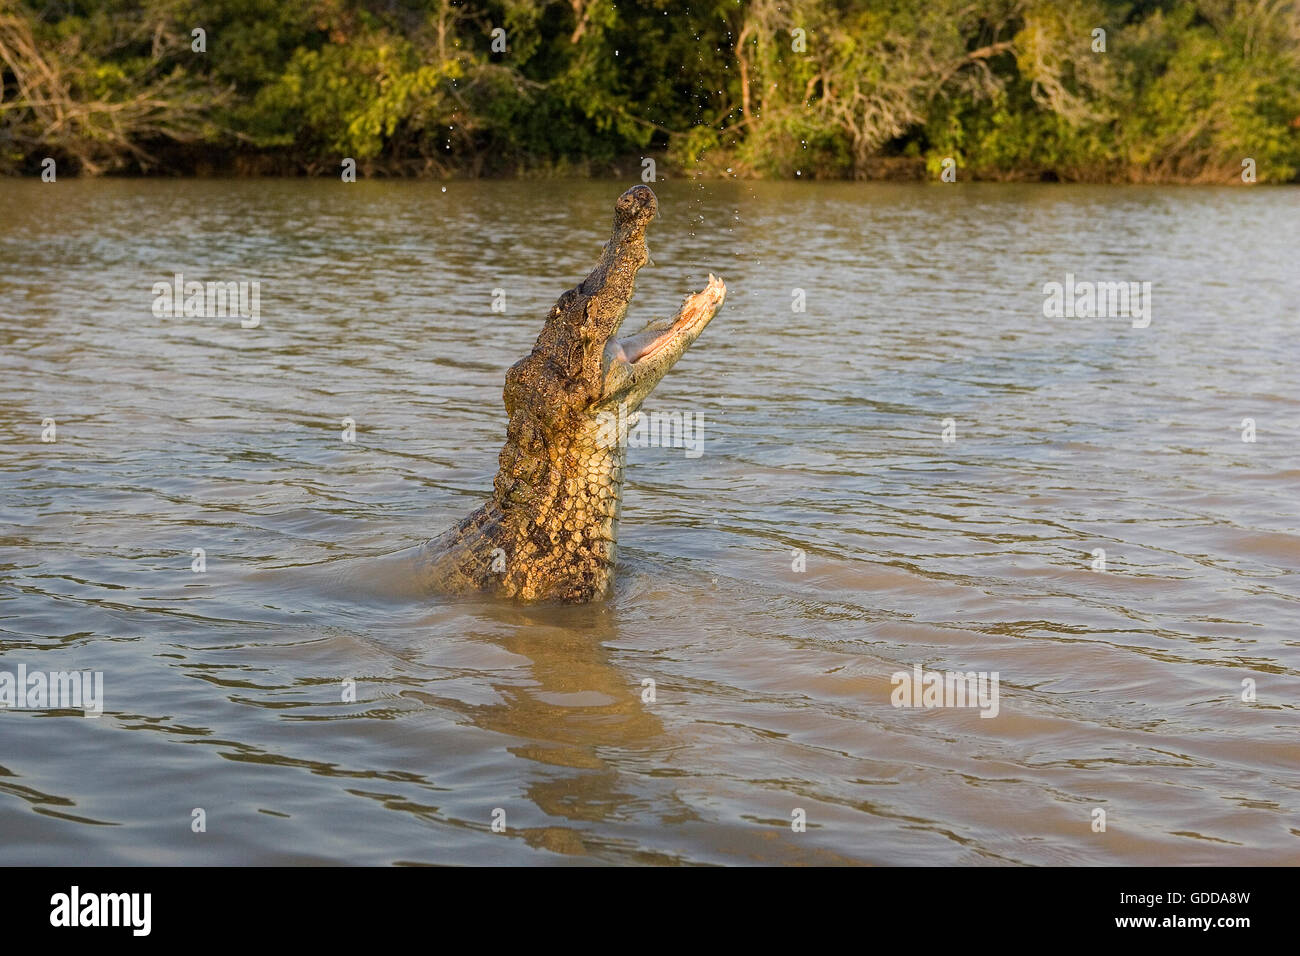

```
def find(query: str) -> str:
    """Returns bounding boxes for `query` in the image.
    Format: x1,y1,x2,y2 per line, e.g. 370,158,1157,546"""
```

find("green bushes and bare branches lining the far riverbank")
0,0,1300,182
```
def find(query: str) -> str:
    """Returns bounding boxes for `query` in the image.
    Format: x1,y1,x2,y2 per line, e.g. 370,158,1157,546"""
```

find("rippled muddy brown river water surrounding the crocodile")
0,181,1300,864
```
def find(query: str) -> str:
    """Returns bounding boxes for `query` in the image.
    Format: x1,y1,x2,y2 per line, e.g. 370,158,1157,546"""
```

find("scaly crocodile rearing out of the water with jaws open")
417,186,727,604
